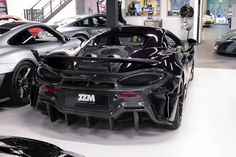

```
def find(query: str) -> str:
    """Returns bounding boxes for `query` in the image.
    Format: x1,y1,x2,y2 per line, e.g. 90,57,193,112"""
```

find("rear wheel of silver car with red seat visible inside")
10,61,35,106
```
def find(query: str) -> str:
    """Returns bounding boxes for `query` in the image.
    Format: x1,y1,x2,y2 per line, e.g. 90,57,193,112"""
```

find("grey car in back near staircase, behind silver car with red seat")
54,14,124,42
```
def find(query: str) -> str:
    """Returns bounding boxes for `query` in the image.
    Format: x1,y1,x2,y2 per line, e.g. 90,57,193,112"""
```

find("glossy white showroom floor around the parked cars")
0,68,236,157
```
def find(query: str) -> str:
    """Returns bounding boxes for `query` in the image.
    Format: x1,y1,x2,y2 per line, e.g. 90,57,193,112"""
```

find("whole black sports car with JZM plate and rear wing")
32,27,196,129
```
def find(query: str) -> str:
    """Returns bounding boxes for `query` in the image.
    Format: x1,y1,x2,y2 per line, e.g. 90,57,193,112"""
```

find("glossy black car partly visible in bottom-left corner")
0,136,84,157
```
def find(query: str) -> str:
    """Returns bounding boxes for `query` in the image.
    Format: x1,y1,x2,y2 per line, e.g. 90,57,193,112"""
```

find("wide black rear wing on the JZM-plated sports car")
40,56,160,72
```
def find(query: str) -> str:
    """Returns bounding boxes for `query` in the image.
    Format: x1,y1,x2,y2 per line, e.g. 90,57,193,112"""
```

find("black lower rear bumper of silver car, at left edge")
0,72,13,103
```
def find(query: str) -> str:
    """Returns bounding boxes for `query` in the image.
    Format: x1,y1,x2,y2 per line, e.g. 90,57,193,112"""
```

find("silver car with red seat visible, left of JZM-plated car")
0,22,80,105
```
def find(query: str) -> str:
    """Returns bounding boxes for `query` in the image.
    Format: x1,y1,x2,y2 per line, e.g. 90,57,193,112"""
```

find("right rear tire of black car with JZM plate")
170,80,185,129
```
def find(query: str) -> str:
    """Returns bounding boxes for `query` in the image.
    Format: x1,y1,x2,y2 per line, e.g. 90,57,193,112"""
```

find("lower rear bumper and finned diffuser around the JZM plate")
35,84,178,129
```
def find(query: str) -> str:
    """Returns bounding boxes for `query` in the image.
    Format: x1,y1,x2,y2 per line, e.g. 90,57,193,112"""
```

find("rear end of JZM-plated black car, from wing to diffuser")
32,56,185,130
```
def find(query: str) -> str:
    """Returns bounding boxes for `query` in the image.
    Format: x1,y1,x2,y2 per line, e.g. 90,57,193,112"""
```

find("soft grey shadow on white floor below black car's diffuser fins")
21,106,179,145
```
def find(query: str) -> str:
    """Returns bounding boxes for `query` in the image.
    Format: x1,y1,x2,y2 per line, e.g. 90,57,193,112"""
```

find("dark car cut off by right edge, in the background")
215,30,236,55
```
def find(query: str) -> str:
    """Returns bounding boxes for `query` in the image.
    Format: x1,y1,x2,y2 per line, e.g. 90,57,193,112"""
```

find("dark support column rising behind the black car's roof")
106,0,118,28
